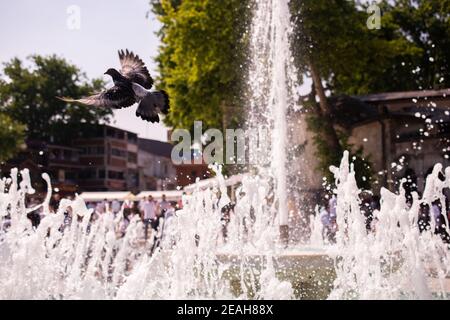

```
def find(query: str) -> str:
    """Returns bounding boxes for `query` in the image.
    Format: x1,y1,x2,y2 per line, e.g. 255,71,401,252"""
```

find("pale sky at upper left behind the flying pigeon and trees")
0,0,167,141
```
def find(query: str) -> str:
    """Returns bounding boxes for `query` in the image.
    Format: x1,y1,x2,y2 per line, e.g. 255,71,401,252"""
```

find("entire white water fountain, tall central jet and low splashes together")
0,0,450,299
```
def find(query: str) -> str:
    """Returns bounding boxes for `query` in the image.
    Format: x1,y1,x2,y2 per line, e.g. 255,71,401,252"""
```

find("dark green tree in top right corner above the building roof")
381,0,450,91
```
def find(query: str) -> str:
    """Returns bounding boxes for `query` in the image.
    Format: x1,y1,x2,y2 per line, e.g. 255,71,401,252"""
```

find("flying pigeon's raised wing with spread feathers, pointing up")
119,49,153,90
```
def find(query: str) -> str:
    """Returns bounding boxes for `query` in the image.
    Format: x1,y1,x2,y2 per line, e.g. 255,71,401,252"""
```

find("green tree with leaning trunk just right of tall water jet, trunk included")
291,0,422,187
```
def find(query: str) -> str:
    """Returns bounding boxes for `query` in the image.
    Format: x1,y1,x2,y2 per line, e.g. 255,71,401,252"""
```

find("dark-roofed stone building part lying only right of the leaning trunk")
350,89,450,191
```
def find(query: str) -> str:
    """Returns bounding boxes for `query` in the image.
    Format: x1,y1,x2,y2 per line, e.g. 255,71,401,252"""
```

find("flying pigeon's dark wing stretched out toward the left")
58,86,136,109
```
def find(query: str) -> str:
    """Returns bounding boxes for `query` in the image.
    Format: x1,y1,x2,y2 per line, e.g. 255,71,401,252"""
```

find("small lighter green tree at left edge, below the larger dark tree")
0,113,26,163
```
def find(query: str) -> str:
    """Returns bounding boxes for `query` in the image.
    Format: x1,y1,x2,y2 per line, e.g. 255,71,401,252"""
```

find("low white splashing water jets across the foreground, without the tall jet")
0,153,450,299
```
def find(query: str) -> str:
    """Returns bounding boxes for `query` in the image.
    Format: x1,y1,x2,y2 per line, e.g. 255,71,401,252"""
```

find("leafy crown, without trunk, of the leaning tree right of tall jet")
292,0,426,95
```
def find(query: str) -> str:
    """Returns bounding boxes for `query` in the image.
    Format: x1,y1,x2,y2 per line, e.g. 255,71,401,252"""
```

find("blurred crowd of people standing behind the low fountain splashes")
7,185,450,248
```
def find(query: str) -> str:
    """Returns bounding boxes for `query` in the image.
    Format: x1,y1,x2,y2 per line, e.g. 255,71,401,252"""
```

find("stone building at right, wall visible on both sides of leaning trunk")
291,89,450,196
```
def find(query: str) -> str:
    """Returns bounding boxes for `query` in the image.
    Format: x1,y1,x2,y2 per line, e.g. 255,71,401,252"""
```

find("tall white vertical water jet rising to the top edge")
248,0,298,240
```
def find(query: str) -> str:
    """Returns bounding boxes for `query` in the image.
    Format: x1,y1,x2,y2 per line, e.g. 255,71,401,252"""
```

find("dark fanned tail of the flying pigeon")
136,91,170,123
